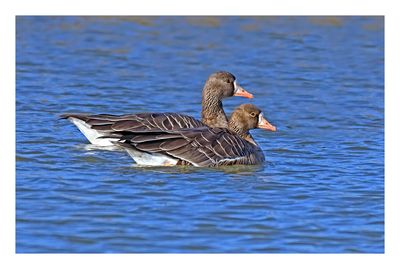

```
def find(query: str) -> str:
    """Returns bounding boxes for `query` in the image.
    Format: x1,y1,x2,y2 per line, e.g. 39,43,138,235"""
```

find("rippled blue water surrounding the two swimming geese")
16,17,384,253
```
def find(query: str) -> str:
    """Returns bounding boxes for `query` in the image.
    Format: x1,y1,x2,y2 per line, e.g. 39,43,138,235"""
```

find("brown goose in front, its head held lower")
116,104,276,167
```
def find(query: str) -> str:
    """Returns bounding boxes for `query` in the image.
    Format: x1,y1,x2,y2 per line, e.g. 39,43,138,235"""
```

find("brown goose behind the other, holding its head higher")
61,71,253,146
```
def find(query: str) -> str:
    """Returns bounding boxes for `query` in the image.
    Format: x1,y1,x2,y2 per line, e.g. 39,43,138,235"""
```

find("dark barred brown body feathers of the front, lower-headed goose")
119,126,264,167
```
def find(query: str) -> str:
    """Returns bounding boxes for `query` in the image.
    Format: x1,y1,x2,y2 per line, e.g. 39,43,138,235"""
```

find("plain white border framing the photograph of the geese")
0,0,400,269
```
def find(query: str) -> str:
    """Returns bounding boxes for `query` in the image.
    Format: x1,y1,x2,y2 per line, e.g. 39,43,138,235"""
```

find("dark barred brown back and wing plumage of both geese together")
61,113,264,166
